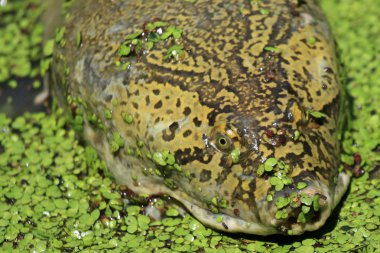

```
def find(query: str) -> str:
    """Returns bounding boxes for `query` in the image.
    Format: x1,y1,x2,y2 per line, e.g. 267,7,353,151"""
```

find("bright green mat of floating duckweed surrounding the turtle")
0,0,380,253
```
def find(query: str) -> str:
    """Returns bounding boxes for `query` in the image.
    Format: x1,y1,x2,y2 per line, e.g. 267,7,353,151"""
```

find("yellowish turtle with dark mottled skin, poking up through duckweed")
52,0,349,235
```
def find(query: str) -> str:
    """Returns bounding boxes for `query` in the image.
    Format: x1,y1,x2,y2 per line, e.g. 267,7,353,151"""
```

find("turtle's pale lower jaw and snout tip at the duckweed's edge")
181,172,350,236
